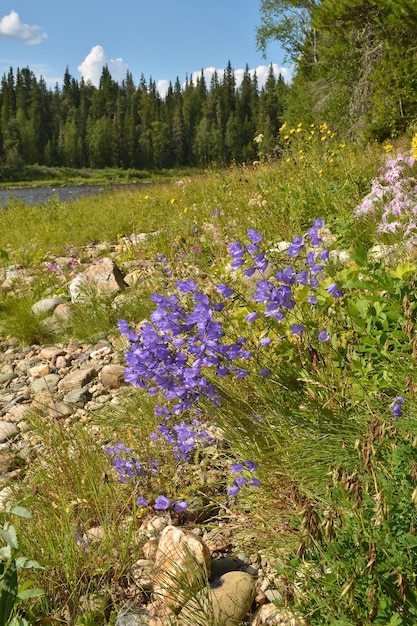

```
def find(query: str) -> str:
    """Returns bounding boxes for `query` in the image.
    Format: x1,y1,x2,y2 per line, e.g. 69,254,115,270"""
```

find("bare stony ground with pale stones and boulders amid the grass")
0,235,301,626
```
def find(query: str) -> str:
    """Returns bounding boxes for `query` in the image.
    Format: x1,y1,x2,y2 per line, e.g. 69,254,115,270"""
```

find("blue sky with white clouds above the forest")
0,0,290,94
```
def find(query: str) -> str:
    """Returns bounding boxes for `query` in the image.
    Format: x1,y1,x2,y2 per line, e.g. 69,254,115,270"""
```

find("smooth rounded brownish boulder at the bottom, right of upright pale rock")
179,572,255,626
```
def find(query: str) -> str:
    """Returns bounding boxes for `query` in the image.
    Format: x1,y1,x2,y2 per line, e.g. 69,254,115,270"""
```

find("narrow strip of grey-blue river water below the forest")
0,185,109,208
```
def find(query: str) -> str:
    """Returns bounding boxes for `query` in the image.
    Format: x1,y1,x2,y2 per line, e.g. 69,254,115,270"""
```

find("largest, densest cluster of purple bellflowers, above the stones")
118,280,251,414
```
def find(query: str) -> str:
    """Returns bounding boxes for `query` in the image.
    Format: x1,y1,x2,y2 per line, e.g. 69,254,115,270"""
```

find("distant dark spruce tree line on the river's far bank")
0,62,288,169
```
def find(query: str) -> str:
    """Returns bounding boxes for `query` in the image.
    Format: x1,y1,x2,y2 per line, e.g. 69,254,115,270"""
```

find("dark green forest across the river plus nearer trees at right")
0,0,417,169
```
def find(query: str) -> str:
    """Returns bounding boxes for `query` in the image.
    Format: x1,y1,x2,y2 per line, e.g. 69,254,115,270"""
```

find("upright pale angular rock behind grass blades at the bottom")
153,526,211,611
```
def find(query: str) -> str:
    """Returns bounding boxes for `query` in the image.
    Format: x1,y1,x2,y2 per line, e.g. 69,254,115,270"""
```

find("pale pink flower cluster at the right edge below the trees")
355,154,417,248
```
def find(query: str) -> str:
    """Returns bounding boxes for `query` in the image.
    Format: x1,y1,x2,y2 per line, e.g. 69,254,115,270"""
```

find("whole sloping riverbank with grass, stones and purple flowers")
4,130,417,626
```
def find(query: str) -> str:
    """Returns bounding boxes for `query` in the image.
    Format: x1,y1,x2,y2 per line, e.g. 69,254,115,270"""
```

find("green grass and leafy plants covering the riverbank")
0,131,417,626
